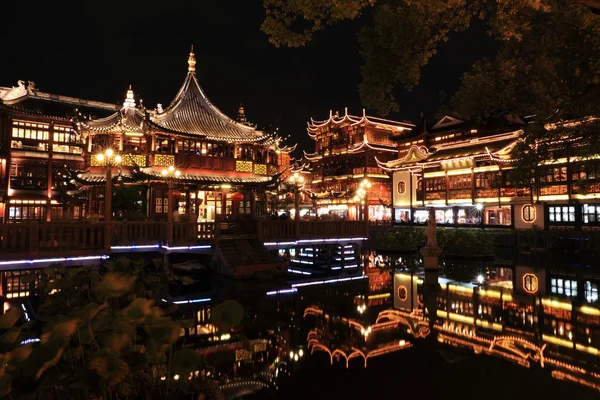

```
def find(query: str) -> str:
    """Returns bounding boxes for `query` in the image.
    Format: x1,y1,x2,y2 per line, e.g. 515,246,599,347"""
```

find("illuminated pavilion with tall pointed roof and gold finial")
76,51,293,221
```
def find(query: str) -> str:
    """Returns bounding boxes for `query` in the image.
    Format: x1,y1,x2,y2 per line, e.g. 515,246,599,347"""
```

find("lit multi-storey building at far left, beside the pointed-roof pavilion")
0,81,117,222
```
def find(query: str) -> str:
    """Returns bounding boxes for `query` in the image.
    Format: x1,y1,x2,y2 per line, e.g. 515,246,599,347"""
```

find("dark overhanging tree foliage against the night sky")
262,0,600,116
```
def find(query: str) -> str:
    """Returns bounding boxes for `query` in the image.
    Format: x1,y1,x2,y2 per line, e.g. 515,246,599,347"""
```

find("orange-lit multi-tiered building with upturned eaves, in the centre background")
305,112,414,220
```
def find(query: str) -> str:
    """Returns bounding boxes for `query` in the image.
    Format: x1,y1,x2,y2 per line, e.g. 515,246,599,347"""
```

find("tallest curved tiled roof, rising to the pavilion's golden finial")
150,71,271,142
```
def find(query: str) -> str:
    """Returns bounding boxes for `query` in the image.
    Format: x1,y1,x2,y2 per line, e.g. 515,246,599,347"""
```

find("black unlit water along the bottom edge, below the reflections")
254,347,600,400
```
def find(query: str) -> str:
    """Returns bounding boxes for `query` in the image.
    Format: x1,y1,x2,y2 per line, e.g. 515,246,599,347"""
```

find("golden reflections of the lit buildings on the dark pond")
168,246,600,397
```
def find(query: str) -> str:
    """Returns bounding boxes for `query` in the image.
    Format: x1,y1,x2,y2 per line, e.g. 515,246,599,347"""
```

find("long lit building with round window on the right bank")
378,116,600,228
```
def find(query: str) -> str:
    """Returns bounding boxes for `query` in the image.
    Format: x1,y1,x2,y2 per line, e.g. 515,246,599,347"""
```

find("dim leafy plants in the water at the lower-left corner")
0,258,213,399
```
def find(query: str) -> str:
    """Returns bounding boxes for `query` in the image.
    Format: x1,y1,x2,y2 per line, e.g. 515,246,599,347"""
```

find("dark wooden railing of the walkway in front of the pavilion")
0,220,368,262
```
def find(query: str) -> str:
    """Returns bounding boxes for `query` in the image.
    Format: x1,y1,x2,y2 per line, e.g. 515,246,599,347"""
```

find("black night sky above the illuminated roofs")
0,0,489,155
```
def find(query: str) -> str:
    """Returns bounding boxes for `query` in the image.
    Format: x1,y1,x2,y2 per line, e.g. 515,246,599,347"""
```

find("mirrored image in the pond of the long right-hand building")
393,266,600,370
